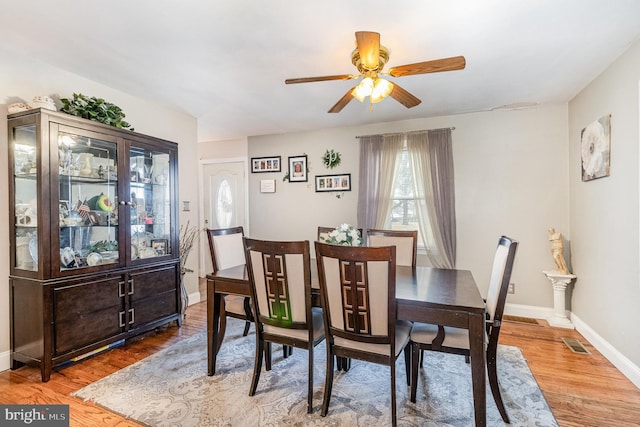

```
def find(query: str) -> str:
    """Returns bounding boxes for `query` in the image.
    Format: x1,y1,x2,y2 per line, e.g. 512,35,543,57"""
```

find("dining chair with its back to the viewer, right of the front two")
315,242,411,426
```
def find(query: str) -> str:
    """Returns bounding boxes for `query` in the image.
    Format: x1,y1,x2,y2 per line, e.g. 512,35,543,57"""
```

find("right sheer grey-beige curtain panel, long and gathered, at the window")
407,128,456,268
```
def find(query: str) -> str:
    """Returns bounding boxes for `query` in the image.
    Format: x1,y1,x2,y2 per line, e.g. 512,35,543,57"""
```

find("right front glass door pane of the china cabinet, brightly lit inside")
129,146,175,261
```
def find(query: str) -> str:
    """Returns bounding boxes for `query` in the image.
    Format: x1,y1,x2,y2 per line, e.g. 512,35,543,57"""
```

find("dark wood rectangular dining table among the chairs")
207,261,486,426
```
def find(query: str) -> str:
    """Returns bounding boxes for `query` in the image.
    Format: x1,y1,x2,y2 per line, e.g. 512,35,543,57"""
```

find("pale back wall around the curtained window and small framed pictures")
249,105,569,309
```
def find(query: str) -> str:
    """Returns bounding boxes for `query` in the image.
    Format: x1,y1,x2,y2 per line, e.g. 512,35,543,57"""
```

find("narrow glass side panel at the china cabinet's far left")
10,124,38,271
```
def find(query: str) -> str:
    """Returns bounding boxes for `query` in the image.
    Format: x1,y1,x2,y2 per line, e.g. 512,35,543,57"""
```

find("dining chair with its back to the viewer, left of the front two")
243,237,325,413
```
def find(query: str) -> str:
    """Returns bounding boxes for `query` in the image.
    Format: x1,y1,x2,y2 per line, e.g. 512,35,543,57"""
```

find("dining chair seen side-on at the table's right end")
410,236,518,423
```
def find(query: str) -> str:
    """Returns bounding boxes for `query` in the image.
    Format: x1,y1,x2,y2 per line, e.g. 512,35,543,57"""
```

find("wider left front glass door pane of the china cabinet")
57,131,120,271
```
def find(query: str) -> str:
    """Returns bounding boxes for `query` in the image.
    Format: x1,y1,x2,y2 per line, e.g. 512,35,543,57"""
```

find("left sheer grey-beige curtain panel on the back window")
358,134,404,228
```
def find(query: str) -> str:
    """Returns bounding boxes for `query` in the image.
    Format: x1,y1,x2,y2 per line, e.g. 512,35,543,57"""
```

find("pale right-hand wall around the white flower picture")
569,39,640,374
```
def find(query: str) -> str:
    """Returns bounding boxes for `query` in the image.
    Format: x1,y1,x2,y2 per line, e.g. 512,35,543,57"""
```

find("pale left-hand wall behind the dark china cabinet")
0,48,198,370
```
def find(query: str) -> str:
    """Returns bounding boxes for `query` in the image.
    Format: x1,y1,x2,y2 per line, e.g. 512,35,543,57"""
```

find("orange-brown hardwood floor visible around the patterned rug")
0,302,640,427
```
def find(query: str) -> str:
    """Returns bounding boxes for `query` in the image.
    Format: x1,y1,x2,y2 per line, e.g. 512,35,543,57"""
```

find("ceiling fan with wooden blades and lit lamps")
284,31,466,113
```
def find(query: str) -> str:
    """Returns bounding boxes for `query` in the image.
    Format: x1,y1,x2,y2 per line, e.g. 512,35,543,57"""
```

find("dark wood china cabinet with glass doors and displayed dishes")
8,109,181,381
